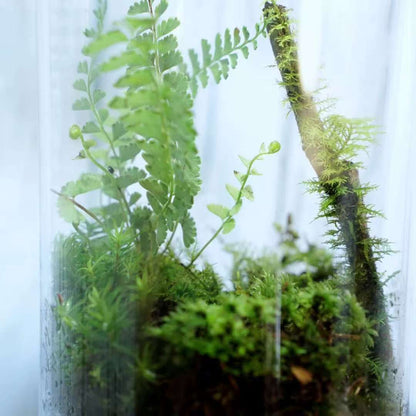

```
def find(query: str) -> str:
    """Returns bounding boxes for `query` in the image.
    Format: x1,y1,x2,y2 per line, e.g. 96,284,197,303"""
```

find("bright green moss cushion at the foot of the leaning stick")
144,221,382,415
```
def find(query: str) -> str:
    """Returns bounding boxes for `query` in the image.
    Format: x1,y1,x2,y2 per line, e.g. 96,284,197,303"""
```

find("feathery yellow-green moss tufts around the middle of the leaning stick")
307,112,390,254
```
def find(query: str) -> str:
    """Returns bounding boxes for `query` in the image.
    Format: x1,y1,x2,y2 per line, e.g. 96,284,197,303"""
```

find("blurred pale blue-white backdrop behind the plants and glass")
0,0,416,416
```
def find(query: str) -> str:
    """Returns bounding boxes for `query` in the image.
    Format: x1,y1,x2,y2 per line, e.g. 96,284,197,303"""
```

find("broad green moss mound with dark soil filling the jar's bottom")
52,224,394,416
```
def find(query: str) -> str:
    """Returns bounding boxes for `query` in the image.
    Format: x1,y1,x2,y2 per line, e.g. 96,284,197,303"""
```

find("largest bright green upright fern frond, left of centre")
84,0,200,249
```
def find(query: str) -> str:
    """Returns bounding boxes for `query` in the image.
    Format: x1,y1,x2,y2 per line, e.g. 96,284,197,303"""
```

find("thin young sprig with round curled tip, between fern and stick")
189,141,280,266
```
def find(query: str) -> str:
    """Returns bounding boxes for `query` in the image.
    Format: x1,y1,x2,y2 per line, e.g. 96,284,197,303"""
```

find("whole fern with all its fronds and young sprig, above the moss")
55,0,280,264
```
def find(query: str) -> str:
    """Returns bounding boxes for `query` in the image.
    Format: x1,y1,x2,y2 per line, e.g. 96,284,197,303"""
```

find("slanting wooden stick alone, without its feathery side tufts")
263,2,391,363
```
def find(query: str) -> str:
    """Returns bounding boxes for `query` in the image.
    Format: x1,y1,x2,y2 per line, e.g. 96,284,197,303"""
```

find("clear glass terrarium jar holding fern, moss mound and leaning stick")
41,0,407,416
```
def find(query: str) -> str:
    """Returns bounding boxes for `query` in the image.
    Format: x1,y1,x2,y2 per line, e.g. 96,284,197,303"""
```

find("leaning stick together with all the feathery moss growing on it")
264,11,397,404
